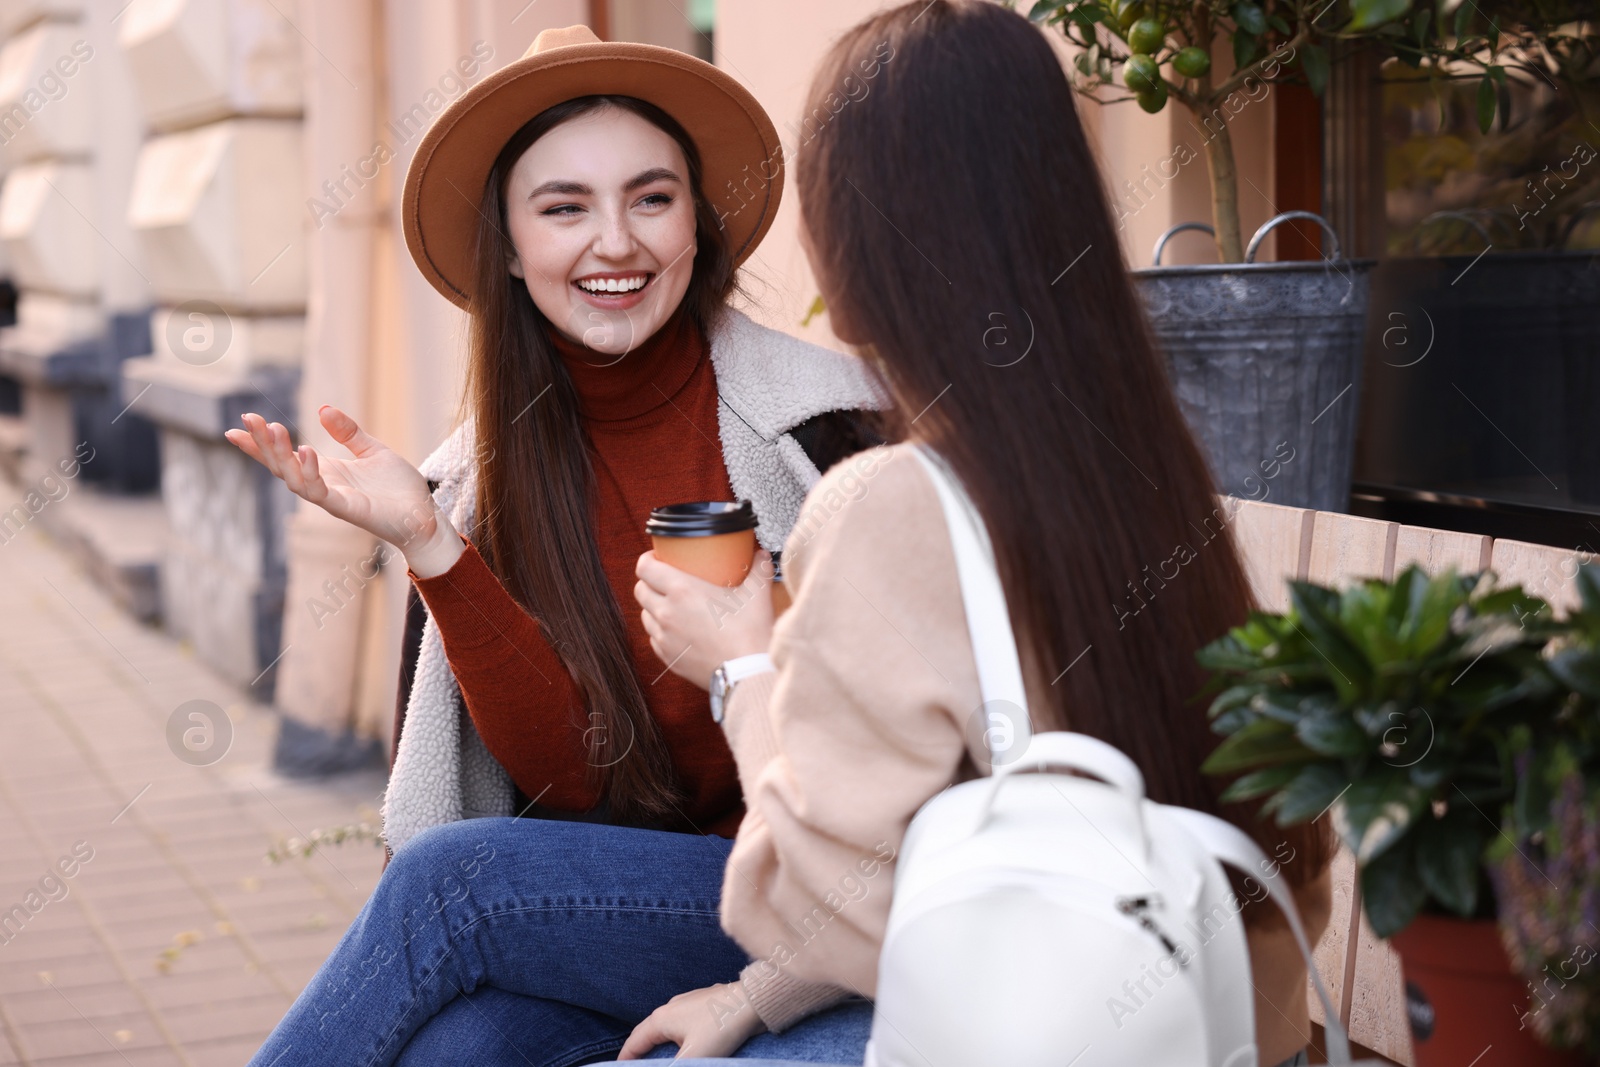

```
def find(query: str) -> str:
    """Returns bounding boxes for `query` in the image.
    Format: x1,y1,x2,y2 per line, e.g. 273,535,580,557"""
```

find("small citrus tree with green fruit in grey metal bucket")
1029,0,1576,510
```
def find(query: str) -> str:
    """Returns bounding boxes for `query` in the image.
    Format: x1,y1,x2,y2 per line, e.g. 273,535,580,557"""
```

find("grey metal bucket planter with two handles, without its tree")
1133,211,1374,512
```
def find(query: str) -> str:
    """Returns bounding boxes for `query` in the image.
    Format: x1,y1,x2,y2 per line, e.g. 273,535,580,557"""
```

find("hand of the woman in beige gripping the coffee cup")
634,549,773,689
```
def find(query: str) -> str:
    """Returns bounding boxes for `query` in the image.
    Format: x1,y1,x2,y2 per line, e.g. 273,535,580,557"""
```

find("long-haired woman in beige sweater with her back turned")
624,0,1330,1065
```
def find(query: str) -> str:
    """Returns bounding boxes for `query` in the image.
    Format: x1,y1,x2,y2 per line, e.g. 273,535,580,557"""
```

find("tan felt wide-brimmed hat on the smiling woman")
402,26,784,307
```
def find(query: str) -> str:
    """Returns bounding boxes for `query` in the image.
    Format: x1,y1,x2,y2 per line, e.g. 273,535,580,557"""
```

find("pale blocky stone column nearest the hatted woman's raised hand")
117,0,307,687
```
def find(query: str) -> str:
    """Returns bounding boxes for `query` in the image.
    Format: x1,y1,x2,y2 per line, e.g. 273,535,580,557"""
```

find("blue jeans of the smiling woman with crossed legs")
251,819,870,1067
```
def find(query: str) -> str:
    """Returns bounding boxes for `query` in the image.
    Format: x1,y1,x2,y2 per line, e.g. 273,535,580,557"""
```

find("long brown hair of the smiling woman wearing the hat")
464,96,734,825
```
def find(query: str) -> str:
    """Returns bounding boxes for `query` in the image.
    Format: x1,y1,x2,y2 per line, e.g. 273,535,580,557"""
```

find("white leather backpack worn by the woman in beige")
866,448,1350,1067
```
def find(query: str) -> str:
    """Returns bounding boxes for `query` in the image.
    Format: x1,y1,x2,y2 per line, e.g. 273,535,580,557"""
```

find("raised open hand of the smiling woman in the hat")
224,405,464,577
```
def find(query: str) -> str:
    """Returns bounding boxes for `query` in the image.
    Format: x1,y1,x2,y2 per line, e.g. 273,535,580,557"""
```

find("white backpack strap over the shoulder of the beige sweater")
910,445,1034,765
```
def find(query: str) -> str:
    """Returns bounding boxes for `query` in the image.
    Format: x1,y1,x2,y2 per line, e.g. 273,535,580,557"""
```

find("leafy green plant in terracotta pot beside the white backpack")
1198,566,1600,1067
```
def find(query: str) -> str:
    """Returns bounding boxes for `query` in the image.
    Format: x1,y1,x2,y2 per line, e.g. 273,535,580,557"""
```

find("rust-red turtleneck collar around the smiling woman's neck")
550,307,706,422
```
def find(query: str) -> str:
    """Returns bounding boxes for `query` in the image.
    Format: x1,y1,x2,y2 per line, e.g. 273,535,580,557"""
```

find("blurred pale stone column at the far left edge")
0,0,155,495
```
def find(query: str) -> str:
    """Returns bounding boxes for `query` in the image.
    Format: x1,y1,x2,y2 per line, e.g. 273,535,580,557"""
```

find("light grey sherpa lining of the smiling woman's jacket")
382,310,888,851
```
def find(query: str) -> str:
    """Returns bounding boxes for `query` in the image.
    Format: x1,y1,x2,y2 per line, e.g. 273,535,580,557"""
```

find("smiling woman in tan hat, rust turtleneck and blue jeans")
227,27,882,1067
